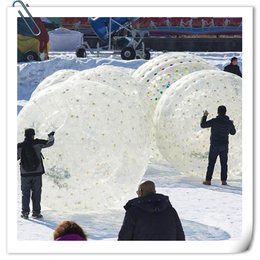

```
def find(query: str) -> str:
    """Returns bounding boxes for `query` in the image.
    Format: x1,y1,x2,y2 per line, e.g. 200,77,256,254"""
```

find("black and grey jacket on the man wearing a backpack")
17,136,54,177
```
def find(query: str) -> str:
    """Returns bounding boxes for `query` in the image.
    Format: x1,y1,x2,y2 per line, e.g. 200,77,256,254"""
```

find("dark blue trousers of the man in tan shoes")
206,143,228,181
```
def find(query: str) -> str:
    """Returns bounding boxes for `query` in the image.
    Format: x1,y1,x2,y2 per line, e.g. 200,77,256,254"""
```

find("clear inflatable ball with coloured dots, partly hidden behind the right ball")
133,52,218,118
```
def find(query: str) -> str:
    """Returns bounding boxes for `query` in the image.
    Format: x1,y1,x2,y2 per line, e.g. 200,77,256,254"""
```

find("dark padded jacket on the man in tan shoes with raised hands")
200,116,236,144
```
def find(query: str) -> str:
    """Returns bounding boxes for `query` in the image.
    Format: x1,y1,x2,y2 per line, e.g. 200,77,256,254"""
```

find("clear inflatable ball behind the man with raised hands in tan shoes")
154,70,242,178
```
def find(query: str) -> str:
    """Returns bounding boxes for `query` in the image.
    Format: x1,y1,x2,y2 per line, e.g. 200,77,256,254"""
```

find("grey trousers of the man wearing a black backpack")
21,175,42,213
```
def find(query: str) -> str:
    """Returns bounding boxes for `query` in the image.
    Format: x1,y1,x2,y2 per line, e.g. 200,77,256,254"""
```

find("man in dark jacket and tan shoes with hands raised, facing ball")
200,106,236,185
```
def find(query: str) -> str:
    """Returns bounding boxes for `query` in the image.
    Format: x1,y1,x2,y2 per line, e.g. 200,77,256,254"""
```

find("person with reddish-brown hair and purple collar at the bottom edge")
53,221,88,241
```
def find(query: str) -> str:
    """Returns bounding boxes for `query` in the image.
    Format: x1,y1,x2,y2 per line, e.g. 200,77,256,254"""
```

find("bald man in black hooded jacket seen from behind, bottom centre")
118,181,185,240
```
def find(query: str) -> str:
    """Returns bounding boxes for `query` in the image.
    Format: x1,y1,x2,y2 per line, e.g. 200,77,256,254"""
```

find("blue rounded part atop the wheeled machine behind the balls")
88,17,139,42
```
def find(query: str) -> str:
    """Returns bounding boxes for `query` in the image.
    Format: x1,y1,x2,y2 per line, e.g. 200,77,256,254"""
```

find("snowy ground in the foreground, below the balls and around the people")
17,158,242,241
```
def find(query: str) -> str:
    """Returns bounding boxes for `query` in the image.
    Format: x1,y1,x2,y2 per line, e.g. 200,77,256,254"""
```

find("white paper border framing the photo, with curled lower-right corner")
7,5,253,253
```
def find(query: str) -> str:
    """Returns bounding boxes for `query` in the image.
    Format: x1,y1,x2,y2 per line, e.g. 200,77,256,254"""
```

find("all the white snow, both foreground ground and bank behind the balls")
17,52,242,241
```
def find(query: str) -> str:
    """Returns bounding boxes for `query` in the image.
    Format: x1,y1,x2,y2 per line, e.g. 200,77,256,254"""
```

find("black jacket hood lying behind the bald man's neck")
124,194,171,213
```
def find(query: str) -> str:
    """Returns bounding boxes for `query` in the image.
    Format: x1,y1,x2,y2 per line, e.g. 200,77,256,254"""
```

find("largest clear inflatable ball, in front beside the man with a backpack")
18,80,149,212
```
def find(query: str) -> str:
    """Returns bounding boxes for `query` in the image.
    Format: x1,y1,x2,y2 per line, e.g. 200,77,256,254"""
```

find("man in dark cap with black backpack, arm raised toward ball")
17,128,55,219
